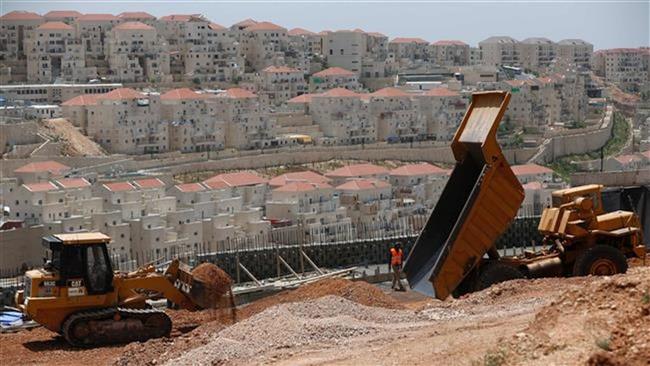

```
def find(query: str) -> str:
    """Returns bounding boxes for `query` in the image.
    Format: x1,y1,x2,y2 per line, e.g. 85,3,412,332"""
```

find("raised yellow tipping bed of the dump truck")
404,92,524,300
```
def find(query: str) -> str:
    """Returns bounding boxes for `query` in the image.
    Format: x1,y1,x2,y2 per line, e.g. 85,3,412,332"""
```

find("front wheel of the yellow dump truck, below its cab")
573,245,627,276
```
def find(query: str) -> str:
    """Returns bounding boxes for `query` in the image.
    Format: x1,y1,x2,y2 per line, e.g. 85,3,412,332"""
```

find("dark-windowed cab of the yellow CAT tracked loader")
43,233,113,295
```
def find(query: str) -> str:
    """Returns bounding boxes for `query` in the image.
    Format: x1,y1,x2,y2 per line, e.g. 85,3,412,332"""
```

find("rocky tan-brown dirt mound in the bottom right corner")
476,267,650,365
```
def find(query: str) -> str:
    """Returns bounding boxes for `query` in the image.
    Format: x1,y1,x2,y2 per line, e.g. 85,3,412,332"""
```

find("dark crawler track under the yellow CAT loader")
62,308,171,347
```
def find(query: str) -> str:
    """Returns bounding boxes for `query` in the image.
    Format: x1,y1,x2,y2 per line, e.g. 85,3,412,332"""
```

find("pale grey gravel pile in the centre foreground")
168,296,430,365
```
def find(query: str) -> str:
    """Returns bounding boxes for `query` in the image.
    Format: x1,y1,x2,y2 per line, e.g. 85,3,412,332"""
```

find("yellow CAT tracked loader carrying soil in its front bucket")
15,233,230,347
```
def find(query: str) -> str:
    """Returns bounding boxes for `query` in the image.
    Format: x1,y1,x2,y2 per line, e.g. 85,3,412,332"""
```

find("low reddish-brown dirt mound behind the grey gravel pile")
237,278,404,319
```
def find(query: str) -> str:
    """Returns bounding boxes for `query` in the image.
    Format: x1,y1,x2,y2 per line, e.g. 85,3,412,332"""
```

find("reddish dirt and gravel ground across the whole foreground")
0,258,650,365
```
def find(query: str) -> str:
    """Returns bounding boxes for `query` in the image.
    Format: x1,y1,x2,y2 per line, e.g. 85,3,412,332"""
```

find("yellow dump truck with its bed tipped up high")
404,91,646,300
